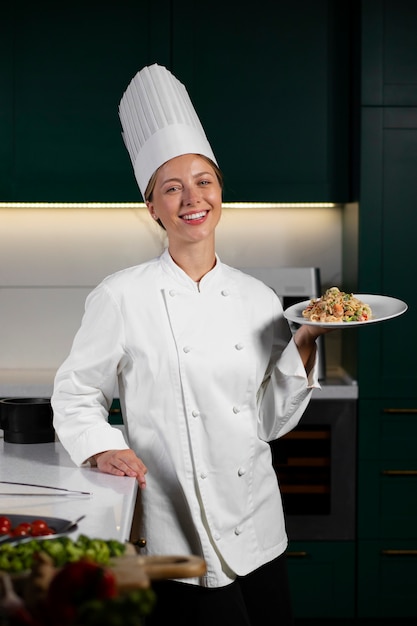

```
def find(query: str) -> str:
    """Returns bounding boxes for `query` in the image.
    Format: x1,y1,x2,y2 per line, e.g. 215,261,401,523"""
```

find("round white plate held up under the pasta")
284,293,408,328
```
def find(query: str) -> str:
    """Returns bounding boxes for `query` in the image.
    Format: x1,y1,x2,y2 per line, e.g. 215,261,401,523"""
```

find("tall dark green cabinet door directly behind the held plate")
358,107,417,398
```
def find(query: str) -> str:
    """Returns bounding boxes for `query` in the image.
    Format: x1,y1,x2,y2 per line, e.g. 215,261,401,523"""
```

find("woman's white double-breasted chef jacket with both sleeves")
52,250,319,587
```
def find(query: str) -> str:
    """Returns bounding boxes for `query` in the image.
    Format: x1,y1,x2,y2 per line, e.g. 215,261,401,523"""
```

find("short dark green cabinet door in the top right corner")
361,0,417,106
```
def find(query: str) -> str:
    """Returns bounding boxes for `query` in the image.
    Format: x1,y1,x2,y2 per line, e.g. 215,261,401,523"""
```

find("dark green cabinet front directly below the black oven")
287,541,355,618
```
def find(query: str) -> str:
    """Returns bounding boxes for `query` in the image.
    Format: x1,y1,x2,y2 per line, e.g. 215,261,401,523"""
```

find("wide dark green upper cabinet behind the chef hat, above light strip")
0,0,356,202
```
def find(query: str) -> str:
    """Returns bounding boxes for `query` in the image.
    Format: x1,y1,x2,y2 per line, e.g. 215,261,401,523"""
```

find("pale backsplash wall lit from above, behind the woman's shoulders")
0,207,343,370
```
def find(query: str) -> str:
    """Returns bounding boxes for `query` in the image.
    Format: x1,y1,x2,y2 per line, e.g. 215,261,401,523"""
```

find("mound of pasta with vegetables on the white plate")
303,287,372,323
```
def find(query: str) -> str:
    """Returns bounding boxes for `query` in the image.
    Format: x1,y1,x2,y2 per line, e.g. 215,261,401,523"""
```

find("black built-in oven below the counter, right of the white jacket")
271,398,357,541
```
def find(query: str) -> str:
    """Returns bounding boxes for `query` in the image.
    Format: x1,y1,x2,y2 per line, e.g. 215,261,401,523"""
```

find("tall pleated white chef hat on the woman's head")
119,64,217,197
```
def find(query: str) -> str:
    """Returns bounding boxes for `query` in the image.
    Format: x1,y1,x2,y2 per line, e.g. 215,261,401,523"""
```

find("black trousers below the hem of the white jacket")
146,555,294,626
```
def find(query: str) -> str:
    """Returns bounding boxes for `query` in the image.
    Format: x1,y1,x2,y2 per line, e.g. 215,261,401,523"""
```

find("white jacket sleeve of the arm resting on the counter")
51,284,129,465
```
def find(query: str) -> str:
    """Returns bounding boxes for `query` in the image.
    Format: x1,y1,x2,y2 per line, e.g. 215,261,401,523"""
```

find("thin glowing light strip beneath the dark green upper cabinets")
0,202,341,209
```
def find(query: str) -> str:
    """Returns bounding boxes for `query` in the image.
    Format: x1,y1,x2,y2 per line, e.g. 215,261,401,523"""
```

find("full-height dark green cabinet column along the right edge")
357,0,417,619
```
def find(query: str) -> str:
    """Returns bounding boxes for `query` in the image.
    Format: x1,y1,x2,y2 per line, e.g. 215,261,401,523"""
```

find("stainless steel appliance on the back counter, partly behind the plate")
240,267,326,380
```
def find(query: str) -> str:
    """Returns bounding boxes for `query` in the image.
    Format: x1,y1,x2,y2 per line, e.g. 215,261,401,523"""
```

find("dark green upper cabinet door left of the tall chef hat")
0,0,170,202
